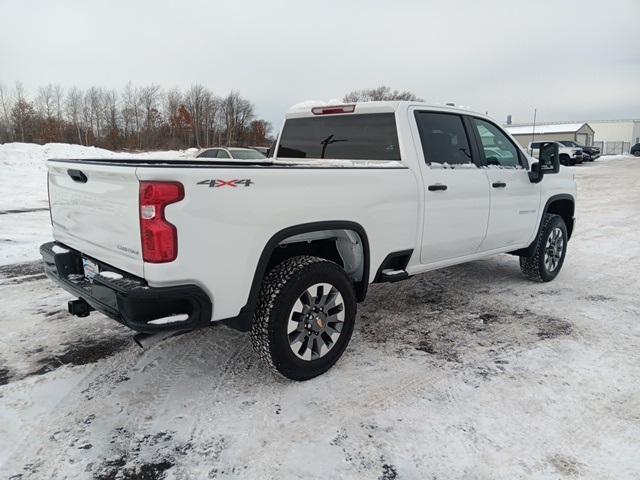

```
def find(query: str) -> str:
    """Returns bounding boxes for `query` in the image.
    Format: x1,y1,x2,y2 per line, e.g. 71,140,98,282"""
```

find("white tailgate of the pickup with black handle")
47,160,144,276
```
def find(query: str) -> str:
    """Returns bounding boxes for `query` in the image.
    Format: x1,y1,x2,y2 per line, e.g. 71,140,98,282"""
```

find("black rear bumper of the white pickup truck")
40,242,211,333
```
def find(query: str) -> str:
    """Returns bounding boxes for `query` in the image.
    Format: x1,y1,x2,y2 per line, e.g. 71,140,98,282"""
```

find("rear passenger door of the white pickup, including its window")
412,109,489,264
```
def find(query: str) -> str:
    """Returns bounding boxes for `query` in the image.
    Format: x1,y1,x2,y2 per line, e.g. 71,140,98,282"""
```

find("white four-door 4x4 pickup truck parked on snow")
41,102,576,380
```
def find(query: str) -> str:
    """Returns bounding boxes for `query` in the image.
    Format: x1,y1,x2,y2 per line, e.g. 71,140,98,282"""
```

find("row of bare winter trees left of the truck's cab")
0,82,272,150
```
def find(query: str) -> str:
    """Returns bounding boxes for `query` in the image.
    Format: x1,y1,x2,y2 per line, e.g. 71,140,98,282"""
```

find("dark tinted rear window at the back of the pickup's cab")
278,113,400,160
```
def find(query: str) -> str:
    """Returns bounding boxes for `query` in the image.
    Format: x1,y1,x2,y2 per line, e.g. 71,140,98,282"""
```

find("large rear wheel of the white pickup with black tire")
250,256,357,380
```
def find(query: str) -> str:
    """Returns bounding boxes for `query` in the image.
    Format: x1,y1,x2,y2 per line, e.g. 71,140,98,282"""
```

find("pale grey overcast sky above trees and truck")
0,0,640,128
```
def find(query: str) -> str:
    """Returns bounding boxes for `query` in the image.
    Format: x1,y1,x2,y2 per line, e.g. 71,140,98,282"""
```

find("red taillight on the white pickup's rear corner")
140,182,184,263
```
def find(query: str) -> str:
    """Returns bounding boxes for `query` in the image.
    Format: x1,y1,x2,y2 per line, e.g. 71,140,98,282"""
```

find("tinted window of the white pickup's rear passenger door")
416,111,473,166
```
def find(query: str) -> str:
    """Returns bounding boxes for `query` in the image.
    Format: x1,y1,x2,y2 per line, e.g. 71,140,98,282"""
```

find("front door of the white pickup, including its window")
469,117,540,251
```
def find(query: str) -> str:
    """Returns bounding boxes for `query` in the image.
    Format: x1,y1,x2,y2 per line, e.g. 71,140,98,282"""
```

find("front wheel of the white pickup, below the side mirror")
520,213,568,282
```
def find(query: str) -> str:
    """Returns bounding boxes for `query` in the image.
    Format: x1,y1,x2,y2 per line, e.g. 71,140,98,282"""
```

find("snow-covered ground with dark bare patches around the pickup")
0,148,640,479
